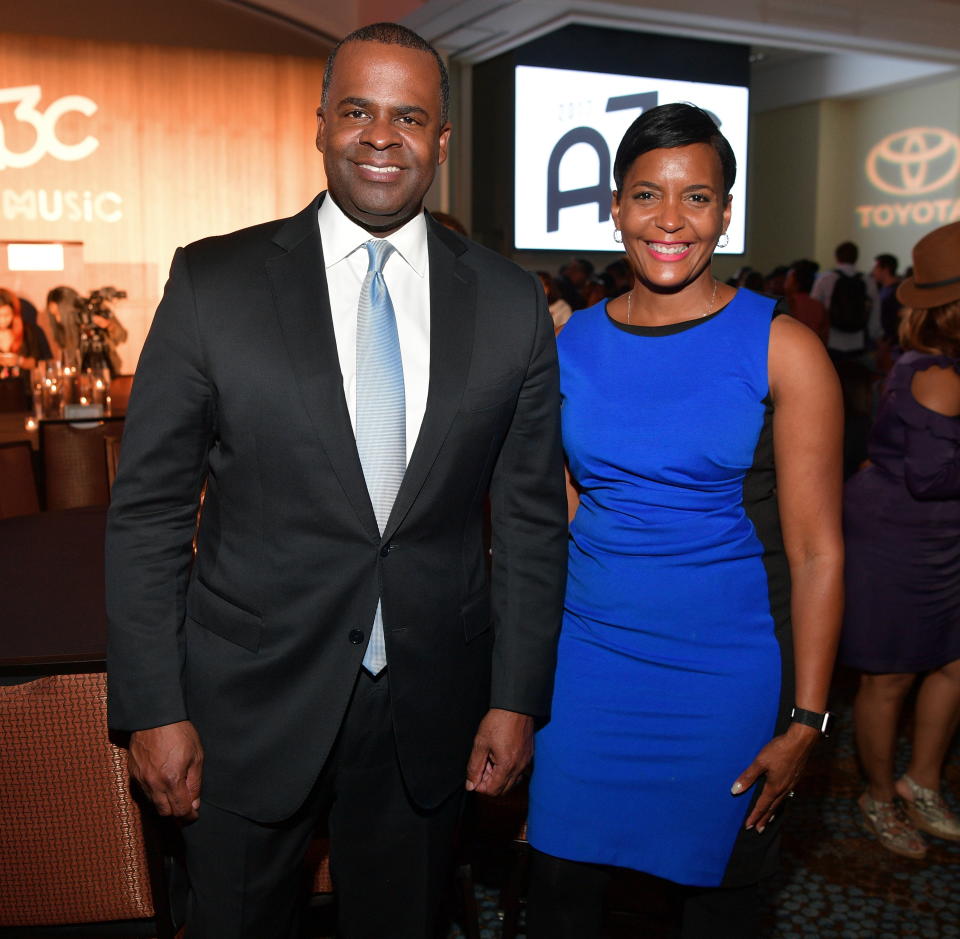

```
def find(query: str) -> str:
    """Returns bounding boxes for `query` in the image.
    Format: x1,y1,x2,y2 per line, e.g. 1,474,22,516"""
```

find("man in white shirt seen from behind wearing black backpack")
810,241,880,360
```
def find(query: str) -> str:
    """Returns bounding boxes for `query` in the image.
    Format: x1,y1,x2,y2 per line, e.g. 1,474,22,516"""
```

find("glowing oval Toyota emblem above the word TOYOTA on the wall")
867,127,960,196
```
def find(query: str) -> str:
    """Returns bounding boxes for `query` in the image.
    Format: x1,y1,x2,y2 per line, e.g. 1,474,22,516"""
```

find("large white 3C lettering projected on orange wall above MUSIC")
0,85,100,170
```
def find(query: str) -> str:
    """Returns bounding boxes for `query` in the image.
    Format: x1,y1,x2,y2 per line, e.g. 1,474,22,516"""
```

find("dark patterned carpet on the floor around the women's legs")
450,674,960,939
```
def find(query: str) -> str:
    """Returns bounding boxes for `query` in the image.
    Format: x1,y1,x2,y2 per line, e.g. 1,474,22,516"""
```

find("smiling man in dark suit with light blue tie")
107,24,566,939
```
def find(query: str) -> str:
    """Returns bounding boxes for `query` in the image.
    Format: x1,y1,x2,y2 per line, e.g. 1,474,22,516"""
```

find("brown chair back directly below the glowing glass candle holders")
40,417,123,510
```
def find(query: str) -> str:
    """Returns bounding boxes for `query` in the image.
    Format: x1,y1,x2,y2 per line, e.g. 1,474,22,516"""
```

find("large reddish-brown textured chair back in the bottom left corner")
0,673,154,932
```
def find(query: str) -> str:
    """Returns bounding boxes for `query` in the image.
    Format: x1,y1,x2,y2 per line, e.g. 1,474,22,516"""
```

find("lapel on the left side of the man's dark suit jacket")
267,196,380,538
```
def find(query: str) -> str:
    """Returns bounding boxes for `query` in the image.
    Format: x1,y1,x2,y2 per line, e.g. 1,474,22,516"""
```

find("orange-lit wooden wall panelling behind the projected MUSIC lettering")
0,34,324,368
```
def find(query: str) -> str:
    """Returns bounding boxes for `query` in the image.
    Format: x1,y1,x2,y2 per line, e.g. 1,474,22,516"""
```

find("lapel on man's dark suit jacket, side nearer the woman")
384,216,477,540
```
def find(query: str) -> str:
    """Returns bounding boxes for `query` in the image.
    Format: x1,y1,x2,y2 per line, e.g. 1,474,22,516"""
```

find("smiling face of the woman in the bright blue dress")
613,143,730,291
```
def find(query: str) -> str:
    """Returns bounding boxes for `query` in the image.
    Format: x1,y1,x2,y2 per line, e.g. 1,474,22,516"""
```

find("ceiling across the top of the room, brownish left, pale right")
7,0,960,110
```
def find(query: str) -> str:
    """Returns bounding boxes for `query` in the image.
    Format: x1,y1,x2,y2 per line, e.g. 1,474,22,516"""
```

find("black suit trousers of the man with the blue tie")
184,670,466,939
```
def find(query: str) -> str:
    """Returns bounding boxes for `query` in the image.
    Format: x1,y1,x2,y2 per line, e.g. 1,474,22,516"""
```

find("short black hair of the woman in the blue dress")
613,103,737,199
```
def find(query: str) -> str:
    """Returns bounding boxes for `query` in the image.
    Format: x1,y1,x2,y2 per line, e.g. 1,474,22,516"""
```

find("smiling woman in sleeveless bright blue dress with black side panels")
528,104,843,939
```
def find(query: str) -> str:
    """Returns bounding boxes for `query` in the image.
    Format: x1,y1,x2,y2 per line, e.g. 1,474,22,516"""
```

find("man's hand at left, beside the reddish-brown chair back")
130,721,203,822
